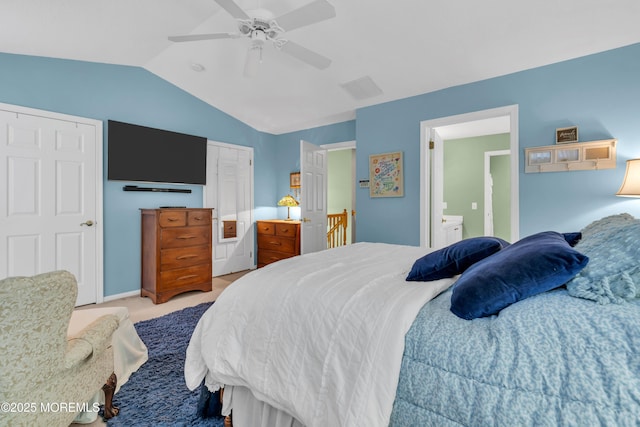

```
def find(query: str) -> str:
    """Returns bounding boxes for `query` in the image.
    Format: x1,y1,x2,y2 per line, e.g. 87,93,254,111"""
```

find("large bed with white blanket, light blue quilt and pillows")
185,214,640,427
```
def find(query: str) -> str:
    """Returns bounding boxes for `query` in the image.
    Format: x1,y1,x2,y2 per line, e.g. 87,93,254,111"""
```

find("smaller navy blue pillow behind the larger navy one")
407,237,509,282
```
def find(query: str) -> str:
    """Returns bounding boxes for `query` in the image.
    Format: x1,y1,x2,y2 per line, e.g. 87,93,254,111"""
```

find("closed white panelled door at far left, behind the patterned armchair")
0,105,103,305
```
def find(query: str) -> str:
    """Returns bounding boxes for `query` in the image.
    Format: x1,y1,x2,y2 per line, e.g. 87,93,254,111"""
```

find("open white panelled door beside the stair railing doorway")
300,141,327,254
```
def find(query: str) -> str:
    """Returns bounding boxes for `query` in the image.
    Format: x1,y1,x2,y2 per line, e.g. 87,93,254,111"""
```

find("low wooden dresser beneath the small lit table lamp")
256,219,300,268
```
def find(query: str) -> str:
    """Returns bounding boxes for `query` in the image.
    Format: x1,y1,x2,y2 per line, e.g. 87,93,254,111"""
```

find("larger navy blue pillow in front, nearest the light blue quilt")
451,231,589,320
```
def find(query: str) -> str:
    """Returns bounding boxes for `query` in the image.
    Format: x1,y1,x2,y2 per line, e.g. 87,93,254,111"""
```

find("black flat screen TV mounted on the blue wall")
107,120,207,185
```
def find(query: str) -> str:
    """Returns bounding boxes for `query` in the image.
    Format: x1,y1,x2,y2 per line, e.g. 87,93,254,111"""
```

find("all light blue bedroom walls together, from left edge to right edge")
0,44,640,296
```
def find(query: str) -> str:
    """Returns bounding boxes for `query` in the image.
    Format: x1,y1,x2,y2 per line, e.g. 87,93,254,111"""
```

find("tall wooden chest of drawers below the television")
140,208,212,304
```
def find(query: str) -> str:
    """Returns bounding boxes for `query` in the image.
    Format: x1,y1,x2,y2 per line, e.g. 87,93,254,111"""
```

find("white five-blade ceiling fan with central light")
169,0,336,76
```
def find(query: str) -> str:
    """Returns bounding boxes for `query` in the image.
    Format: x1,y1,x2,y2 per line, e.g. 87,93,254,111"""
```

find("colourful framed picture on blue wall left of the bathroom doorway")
369,151,404,197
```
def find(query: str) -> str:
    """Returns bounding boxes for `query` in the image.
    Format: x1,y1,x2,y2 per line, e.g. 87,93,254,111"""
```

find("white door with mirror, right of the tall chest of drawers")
204,141,254,276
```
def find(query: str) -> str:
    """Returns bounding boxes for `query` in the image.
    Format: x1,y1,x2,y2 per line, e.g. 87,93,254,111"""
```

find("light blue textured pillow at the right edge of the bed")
567,214,640,304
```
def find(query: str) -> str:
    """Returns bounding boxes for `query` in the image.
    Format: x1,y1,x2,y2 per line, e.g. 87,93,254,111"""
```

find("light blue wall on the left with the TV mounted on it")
0,54,276,296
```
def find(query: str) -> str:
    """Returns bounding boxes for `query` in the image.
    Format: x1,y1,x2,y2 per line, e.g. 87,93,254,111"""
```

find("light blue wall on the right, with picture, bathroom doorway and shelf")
356,44,640,245
